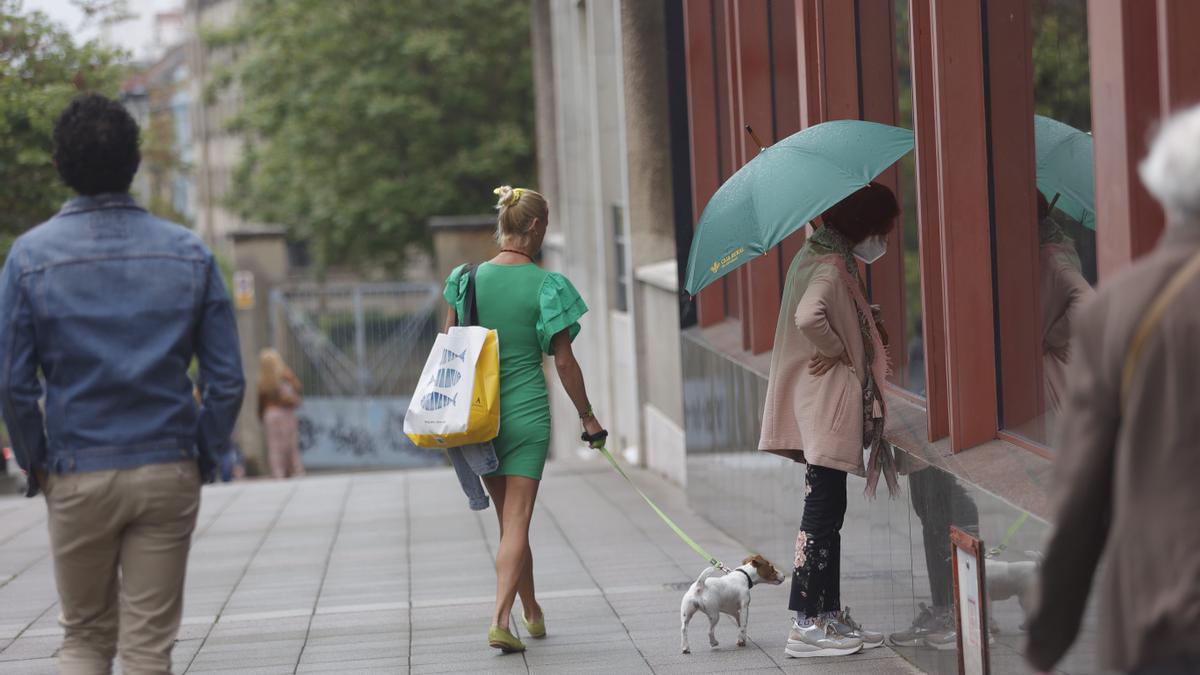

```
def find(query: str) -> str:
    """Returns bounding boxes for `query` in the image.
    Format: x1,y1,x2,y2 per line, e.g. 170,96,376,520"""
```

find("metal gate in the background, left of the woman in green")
270,283,444,467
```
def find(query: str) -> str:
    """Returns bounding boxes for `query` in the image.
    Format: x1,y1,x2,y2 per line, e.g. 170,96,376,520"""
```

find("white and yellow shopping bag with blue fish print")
404,325,499,448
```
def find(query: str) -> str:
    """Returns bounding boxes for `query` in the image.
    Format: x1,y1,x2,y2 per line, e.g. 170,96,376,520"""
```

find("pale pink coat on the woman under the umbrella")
758,253,868,476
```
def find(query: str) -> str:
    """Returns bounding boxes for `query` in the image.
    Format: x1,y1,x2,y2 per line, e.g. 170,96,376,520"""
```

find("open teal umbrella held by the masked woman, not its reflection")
684,120,913,295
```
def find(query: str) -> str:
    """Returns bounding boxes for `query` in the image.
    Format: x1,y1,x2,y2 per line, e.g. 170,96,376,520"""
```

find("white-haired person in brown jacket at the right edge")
1025,100,1200,675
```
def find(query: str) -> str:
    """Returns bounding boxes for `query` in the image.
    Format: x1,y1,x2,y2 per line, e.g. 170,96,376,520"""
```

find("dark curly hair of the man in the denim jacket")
54,94,142,195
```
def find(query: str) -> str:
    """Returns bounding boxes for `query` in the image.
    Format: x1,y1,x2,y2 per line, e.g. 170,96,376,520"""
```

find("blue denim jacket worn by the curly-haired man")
0,195,245,496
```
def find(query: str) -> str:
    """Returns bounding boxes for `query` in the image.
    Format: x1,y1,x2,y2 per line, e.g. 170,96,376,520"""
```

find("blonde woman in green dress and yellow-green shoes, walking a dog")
445,185,604,652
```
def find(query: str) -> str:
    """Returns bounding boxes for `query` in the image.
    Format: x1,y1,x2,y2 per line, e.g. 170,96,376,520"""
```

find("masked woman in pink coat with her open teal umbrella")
684,120,913,657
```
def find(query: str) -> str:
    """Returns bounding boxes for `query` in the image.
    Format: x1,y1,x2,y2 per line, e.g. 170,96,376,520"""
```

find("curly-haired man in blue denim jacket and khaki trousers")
0,95,245,674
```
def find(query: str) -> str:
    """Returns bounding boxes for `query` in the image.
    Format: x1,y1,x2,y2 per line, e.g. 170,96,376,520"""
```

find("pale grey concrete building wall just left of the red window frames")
533,0,684,483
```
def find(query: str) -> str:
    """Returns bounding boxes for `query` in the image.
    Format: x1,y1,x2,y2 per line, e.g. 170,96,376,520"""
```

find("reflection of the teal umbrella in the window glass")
1033,115,1096,229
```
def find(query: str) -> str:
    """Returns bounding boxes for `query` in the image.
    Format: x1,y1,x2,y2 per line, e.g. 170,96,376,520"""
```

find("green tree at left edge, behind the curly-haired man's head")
0,0,125,255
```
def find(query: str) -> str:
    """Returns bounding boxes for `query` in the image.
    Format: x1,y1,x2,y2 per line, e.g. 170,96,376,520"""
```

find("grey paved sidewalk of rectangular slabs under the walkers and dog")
0,461,914,674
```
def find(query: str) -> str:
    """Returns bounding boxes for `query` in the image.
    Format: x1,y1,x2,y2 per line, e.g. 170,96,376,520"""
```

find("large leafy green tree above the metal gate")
216,0,533,270
